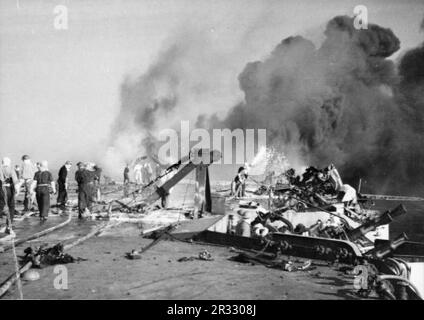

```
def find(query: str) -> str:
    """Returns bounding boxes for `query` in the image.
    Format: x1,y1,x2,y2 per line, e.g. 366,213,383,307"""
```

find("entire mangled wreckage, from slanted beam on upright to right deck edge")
3,149,424,300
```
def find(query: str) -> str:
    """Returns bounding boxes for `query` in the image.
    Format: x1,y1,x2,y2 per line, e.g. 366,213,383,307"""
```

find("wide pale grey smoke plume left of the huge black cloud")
103,28,240,176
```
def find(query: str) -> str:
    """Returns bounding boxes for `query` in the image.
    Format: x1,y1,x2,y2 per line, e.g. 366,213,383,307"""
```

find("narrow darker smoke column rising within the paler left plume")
110,44,184,163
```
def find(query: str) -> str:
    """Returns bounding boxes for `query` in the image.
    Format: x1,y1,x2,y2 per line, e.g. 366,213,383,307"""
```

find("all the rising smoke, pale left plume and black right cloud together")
109,16,424,194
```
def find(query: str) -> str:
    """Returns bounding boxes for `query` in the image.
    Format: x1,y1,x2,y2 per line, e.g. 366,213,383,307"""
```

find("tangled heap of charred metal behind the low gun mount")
248,165,384,240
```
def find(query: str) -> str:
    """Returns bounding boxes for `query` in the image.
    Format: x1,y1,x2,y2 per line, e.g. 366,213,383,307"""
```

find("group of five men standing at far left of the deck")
0,155,101,231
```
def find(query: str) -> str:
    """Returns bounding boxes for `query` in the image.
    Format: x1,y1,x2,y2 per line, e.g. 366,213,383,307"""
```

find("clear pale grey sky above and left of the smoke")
0,0,424,175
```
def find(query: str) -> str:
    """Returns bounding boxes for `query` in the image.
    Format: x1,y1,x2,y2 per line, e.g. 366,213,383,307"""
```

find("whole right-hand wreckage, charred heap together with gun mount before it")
230,165,424,299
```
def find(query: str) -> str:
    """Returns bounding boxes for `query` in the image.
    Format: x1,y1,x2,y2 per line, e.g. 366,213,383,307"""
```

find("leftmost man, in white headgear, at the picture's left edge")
0,157,19,229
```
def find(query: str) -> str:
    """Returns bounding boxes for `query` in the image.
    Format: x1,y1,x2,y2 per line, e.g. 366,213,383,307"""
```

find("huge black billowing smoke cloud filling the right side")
200,16,424,193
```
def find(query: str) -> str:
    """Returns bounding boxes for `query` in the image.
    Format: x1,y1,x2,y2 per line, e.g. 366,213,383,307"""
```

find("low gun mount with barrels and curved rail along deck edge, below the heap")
234,204,422,300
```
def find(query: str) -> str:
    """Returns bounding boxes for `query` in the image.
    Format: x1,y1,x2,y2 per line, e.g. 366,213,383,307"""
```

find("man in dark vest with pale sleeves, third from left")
31,160,56,221
